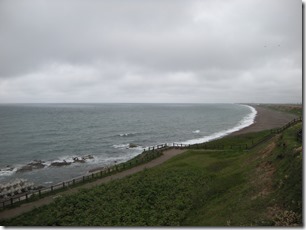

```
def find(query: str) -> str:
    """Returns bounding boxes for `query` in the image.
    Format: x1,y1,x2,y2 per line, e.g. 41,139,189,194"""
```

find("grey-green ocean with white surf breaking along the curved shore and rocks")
0,104,256,186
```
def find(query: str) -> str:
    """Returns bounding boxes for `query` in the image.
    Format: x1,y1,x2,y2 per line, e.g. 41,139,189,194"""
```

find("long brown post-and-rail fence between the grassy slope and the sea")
0,117,302,209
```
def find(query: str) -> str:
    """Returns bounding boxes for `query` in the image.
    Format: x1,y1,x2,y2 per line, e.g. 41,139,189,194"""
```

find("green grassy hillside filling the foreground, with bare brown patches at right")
1,124,302,226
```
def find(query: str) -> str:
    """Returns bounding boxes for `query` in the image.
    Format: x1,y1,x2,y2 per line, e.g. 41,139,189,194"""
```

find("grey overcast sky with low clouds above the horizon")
0,0,302,103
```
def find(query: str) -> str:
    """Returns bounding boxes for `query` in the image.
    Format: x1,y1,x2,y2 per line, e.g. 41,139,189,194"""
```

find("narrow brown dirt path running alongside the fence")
0,149,186,220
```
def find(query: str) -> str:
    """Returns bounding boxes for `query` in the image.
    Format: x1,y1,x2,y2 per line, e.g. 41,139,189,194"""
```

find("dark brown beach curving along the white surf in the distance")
231,104,297,135
